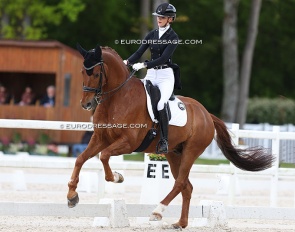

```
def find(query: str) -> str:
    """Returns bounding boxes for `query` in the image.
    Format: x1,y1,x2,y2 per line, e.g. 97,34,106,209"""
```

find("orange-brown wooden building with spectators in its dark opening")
0,40,91,144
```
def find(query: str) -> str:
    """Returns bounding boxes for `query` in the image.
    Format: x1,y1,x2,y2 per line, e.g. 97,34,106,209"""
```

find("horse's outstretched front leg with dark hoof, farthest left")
67,136,105,208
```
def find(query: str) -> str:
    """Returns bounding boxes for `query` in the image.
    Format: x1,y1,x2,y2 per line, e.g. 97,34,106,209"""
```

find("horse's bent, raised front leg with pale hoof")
100,139,132,183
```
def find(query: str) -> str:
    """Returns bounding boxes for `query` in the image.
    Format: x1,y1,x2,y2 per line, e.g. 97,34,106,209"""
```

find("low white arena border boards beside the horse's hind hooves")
0,199,295,228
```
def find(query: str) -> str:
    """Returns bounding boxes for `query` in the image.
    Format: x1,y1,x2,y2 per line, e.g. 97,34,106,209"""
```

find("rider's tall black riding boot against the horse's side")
156,104,169,154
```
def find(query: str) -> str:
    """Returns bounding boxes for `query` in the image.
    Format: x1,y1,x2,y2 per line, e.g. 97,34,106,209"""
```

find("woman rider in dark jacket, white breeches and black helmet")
124,3,178,154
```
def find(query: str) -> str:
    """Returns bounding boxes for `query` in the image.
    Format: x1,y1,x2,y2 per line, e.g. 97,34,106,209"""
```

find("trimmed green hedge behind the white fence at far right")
247,98,295,125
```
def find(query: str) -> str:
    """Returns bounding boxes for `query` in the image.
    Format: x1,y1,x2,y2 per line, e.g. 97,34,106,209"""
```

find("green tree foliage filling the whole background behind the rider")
0,0,295,115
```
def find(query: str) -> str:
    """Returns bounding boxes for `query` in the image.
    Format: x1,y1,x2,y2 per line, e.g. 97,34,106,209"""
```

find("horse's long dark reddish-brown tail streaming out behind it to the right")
211,114,275,171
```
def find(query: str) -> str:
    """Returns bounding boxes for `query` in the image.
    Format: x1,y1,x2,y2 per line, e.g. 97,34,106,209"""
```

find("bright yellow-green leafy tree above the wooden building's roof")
0,0,85,40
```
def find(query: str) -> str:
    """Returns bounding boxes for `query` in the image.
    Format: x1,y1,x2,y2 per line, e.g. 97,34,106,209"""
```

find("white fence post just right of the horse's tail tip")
270,126,280,207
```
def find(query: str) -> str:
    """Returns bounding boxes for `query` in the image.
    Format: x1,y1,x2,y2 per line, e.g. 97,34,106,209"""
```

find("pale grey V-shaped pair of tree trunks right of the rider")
222,0,261,126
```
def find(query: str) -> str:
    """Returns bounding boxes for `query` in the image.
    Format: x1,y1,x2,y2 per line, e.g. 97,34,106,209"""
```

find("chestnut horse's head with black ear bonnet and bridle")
77,44,106,110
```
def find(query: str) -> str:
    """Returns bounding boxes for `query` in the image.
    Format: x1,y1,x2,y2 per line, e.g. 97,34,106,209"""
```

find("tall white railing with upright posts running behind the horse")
0,119,295,213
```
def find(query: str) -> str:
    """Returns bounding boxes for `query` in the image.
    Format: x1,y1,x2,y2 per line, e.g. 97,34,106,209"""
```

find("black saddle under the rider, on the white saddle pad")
145,80,175,121
